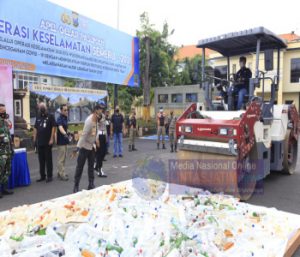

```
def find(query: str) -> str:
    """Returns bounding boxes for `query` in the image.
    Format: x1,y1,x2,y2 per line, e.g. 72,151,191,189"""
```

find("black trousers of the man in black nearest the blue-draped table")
38,145,53,179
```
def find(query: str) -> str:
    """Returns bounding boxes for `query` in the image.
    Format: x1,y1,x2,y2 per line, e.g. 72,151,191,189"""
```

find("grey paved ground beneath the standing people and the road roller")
0,139,300,257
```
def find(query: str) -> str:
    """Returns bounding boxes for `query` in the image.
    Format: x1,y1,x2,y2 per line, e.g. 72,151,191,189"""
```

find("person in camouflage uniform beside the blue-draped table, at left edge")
0,104,14,198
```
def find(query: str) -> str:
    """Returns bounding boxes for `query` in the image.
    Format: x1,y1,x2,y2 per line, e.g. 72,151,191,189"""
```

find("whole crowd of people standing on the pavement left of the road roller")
0,102,177,198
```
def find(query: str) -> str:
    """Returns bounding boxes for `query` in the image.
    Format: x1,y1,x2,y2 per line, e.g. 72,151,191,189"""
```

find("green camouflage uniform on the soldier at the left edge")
0,118,13,186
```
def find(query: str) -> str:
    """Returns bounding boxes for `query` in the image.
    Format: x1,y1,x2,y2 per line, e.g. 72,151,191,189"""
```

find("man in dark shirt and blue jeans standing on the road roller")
233,56,252,110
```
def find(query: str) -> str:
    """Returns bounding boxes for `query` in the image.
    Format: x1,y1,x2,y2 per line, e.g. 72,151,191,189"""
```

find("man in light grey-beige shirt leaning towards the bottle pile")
73,105,102,193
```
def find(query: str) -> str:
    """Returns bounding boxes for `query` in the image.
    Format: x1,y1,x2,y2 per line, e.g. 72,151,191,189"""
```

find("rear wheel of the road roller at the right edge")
283,129,298,175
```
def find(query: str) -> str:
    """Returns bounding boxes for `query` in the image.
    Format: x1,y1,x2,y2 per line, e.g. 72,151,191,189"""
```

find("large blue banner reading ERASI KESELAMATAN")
0,0,139,86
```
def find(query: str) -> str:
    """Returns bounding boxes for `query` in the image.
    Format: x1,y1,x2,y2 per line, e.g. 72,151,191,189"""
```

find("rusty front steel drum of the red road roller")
175,146,258,201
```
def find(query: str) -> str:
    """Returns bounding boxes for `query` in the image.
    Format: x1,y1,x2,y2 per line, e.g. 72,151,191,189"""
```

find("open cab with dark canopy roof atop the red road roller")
197,27,286,111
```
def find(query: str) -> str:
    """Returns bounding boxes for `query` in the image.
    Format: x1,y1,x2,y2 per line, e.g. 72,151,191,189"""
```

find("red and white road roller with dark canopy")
175,27,299,200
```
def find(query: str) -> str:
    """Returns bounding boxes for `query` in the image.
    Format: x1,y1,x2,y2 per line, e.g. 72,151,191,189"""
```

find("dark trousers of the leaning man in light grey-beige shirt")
75,148,95,185
